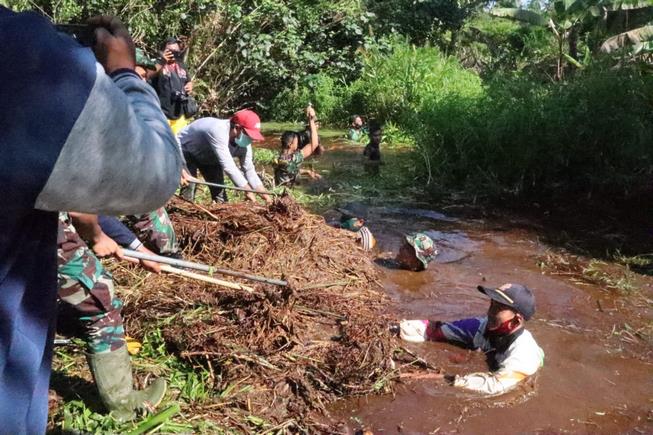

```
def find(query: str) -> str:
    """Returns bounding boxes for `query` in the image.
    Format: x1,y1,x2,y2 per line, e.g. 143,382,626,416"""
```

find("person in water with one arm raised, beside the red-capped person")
274,106,319,186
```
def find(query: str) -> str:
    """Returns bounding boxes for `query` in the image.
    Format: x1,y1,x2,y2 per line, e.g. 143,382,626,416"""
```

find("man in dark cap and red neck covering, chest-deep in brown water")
399,284,544,395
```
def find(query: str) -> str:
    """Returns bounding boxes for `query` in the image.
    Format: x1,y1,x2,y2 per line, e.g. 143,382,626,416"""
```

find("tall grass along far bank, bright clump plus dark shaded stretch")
342,44,653,194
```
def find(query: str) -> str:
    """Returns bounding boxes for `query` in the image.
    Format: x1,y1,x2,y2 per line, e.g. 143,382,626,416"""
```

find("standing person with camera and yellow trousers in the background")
151,38,197,134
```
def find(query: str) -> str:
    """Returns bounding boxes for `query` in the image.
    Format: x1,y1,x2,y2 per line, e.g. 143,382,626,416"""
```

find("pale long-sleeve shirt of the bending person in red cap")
177,118,263,189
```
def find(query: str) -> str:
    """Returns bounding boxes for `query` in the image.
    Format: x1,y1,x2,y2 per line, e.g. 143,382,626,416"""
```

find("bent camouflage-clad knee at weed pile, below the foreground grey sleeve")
127,207,179,255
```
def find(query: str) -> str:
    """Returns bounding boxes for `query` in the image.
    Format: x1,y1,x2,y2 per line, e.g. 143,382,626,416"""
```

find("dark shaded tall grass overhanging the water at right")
415,67,653,193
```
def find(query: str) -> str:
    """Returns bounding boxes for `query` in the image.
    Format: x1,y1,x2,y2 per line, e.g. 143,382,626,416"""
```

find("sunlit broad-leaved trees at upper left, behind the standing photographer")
7,0,373,113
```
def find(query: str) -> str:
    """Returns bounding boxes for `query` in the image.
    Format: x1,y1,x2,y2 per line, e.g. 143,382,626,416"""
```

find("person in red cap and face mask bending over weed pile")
177,109,272,204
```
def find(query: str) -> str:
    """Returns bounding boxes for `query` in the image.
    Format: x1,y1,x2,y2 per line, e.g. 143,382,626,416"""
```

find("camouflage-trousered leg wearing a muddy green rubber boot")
57,213,166,421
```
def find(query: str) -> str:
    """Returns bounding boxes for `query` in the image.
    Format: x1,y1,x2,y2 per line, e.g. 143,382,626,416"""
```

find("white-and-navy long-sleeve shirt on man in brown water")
399,317,544,395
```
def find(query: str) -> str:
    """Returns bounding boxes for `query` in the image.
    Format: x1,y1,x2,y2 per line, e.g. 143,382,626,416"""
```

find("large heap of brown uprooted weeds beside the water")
114,197,396,431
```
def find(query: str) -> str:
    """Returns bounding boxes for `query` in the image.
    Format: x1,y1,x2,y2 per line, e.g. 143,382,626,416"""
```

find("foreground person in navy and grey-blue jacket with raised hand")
0,11,181,434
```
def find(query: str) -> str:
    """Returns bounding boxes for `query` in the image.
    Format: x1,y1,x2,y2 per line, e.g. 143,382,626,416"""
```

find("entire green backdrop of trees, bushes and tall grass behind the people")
5,0,653,194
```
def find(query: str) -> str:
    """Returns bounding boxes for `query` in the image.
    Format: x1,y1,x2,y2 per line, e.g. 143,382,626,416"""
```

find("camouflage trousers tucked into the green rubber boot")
57,213,125,354
